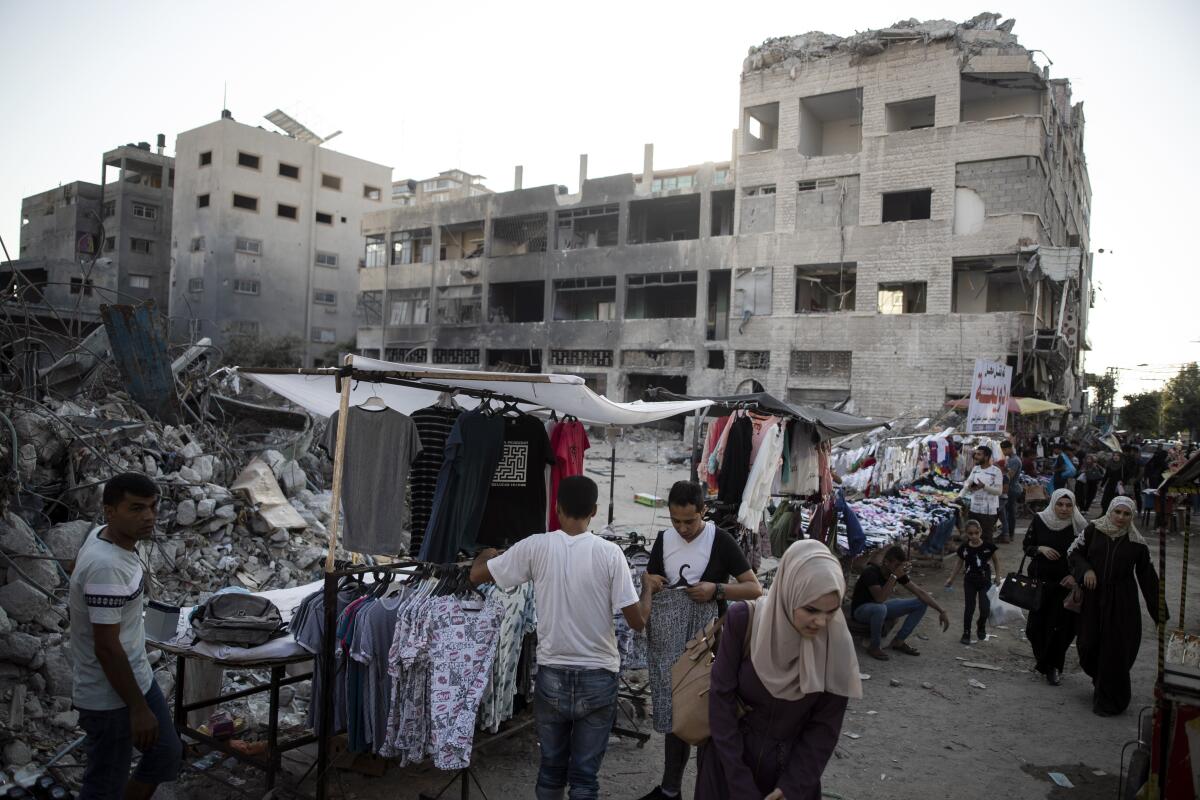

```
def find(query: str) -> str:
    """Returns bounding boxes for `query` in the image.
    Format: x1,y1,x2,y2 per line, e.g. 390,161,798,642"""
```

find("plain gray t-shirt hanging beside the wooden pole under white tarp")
325,407,421,555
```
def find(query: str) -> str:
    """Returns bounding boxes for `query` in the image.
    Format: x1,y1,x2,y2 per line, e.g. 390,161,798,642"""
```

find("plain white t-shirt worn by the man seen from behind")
487,530,637,673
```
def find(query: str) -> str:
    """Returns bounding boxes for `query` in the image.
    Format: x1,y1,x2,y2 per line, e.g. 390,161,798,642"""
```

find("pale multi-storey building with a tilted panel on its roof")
170,114,391,365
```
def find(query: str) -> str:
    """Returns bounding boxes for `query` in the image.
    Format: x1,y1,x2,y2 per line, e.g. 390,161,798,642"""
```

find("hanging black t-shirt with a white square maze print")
475,415,554,547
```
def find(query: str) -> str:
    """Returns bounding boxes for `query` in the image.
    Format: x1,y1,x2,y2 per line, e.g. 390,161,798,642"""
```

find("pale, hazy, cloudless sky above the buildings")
0,0,1200,393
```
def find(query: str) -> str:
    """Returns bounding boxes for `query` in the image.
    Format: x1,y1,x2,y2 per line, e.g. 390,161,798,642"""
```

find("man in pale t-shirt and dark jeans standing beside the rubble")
70,473,184,800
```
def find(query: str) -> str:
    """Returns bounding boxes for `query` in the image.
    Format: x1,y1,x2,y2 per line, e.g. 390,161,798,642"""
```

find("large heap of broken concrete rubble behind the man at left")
0,367,330,774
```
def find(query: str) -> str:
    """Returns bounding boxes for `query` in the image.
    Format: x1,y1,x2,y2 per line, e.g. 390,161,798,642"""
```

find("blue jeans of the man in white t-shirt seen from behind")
533,667,617,800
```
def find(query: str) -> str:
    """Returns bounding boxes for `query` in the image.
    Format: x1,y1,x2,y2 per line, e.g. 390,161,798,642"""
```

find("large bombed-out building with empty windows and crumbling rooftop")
356,14,1091,415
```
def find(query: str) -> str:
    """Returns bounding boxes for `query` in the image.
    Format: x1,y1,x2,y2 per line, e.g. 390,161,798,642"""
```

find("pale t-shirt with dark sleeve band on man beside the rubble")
71,528,154,711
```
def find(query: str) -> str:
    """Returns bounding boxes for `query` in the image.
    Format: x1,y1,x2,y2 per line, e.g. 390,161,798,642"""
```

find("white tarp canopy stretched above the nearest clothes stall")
240,355,713,425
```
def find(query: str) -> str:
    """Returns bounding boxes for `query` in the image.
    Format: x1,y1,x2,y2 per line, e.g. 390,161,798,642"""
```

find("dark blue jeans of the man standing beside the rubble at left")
79,681,184,800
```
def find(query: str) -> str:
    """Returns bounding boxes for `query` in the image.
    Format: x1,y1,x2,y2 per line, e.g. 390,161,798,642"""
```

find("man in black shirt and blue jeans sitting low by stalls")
850,545,950,661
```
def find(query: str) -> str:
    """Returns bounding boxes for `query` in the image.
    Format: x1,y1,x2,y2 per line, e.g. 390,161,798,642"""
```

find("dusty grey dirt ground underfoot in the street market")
176,443,1200,800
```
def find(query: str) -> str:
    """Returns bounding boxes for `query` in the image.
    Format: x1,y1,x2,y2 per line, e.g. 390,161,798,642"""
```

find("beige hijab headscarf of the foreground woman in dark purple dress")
750,539,863,700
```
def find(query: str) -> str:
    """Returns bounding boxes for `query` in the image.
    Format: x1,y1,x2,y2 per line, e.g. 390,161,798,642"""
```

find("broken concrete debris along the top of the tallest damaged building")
742,12,1025,74
